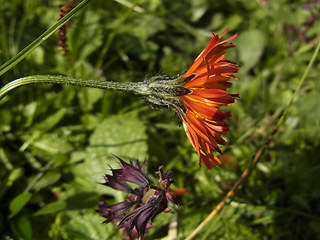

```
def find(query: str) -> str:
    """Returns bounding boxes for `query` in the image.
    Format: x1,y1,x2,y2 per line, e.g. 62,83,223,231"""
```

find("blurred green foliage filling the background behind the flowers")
0,0,320,240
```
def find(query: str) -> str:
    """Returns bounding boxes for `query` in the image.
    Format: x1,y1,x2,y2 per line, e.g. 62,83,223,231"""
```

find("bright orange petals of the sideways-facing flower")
179,29,239,169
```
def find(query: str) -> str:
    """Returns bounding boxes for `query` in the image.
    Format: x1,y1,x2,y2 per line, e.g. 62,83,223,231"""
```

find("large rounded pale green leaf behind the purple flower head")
73,114,148,191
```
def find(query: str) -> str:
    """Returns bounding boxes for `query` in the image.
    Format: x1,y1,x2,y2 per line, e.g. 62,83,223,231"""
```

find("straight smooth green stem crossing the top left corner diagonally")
0,0,91,76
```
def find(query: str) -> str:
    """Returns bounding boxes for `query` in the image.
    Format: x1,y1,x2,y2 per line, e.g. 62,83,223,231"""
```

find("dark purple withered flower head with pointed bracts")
98,157,178,239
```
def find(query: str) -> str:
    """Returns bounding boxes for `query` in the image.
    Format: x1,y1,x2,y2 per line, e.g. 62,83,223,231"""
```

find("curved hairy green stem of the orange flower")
0,75,149,100
